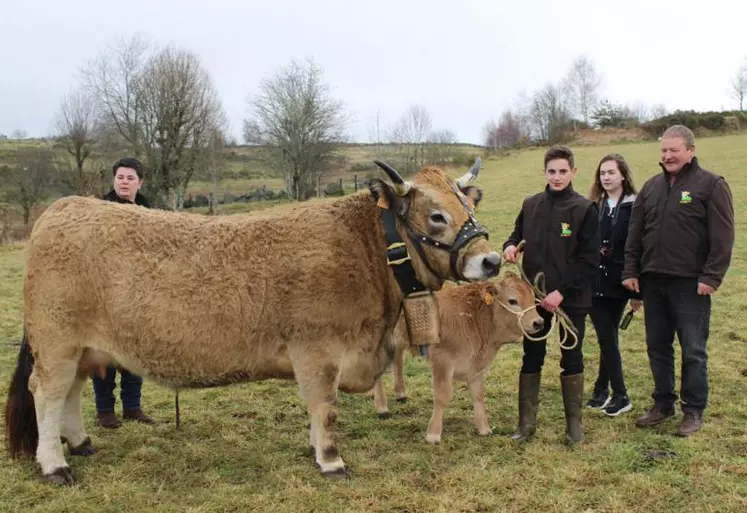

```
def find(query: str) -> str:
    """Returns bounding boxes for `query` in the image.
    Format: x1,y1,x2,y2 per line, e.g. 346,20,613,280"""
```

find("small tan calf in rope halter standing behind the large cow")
374,273,544,444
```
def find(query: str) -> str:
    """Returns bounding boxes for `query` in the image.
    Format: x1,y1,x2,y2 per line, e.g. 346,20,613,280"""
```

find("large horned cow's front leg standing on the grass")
291,348,348,477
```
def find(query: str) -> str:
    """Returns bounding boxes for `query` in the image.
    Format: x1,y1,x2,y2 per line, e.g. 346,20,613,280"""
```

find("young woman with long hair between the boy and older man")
586,153,641,417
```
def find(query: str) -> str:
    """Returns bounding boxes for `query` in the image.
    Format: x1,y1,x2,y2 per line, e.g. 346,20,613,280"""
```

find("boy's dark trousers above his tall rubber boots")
521,305,586,376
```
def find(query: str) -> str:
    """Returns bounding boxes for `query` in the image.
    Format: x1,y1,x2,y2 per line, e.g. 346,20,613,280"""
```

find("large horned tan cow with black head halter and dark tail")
5,163,500,484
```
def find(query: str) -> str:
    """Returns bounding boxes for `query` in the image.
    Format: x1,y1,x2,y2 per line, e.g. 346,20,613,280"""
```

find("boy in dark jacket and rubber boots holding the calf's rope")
503,146,599,444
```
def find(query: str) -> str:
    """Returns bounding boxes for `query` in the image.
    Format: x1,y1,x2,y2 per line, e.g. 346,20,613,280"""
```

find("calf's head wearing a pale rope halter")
485,272,545,340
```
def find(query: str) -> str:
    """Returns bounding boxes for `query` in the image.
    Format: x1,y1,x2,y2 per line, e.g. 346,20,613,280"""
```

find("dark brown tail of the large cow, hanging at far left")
5,329,39,458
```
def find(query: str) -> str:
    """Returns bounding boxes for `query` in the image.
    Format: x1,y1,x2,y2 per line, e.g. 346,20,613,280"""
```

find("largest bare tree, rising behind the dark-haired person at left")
83,36,225,210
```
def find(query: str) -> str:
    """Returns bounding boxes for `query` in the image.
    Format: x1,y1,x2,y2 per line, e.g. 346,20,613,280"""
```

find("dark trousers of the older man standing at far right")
641,277,711,411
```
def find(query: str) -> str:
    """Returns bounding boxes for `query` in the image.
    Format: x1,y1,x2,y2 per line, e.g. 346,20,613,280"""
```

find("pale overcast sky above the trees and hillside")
0,0,747,143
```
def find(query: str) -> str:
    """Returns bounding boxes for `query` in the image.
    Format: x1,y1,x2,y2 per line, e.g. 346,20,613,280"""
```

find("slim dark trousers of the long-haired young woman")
590,297,628,395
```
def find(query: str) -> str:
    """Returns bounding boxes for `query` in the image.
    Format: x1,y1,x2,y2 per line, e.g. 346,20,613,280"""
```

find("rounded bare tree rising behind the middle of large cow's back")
244,61,348,200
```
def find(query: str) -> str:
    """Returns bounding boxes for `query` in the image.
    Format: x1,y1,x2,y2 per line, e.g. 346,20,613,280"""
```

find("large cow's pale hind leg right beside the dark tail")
29,360,78,484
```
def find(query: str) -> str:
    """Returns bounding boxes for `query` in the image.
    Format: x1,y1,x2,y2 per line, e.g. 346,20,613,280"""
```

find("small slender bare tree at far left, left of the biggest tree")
56,90,98,195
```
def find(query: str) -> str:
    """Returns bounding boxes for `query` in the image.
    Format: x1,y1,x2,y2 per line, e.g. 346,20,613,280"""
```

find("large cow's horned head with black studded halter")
370,159,501,289
